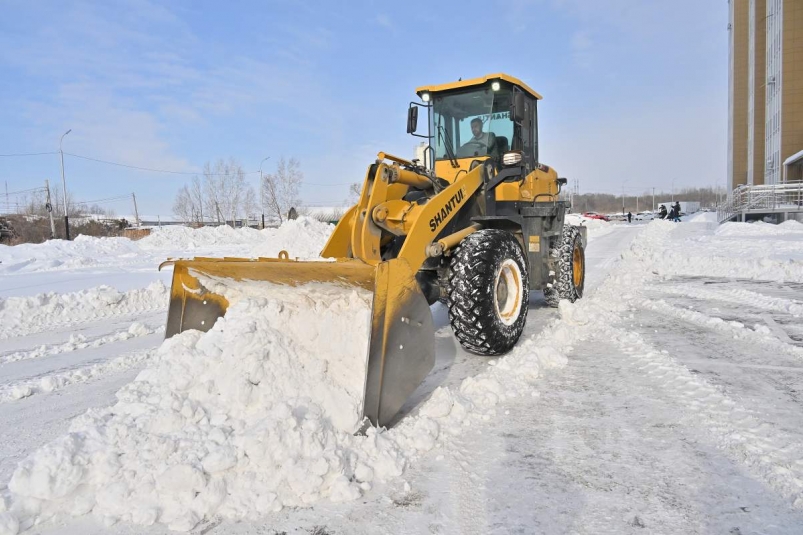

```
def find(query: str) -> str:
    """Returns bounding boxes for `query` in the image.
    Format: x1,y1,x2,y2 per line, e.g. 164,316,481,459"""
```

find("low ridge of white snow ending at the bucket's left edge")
0,281,168,340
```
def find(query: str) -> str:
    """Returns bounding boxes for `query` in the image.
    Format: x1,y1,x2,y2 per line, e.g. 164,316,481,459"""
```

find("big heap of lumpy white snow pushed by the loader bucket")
0,285,412,533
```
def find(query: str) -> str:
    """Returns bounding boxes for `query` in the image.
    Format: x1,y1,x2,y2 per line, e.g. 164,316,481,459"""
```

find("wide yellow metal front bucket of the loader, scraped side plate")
160,253,435,431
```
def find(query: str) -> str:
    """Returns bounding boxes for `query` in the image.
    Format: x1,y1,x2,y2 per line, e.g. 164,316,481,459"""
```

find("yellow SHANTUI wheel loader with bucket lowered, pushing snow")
166,74,586,432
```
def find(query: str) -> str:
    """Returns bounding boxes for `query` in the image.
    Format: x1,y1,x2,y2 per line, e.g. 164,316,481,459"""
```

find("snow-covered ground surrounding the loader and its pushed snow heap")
0,218,803,534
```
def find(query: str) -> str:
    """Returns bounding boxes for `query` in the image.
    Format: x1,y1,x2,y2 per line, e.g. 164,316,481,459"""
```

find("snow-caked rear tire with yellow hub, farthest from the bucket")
544,225,586,307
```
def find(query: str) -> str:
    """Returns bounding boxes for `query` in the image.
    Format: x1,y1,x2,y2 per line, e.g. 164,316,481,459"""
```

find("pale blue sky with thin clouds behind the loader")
0,0,727,215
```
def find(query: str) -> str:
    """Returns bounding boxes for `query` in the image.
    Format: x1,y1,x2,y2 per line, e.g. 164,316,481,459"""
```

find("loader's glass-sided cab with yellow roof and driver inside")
408,74,541,181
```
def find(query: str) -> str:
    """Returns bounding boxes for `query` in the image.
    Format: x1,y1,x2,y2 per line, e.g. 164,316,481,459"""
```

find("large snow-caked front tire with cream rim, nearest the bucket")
447,229,529,355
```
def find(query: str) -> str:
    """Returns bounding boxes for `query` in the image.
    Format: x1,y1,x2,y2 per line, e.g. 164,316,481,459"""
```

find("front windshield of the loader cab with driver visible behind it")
432,88,513,164
